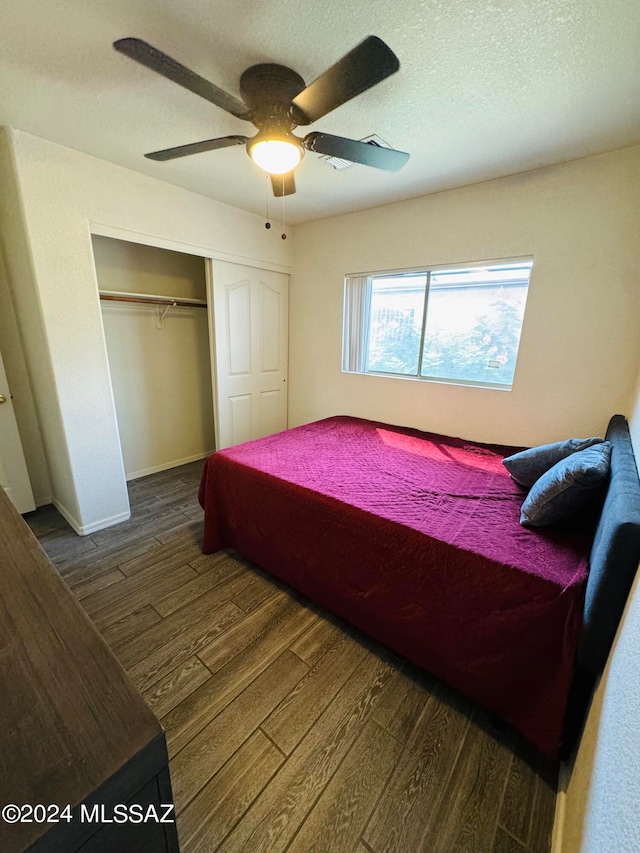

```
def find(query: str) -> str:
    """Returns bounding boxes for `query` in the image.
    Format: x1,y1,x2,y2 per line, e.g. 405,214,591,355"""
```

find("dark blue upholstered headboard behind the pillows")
578,415,640,675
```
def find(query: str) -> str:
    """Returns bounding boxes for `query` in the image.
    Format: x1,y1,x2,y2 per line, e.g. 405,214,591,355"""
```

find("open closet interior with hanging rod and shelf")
91,235,215,480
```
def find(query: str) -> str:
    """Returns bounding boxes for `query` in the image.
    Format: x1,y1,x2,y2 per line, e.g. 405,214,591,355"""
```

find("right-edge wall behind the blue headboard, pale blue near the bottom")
555,364,640,853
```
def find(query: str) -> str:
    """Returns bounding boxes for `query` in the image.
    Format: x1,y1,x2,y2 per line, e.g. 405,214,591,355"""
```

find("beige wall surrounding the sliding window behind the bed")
289,148,640,444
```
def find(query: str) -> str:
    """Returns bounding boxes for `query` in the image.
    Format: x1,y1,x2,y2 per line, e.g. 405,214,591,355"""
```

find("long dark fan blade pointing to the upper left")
113,38,253,121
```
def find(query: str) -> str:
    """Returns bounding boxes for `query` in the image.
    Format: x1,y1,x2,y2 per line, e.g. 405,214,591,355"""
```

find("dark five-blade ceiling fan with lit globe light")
113,36,409,196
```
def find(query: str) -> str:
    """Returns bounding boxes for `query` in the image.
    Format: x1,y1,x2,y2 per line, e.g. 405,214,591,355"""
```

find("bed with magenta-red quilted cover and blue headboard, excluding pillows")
200,416,640,756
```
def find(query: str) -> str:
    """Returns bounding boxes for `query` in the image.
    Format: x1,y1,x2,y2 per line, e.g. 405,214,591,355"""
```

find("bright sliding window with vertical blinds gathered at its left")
343,259,533,389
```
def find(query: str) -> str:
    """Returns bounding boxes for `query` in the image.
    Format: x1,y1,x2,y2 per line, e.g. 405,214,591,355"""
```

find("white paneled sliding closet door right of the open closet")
209,261,289,449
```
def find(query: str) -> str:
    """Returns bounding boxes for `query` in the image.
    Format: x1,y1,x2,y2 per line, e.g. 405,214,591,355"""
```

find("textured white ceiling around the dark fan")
0,0,640,223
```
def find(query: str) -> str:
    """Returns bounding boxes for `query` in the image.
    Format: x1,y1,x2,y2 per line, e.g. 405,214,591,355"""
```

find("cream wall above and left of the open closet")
2,130,291,533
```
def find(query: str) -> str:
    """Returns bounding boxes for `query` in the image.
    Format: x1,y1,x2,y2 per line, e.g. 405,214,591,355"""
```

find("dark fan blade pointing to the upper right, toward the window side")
292,36,400,124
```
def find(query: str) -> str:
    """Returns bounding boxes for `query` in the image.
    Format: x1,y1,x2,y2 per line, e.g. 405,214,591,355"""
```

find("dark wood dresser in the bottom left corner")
0,488,178,853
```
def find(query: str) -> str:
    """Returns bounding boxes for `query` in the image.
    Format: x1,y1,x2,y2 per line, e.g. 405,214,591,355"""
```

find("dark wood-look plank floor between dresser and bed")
26,463,557,853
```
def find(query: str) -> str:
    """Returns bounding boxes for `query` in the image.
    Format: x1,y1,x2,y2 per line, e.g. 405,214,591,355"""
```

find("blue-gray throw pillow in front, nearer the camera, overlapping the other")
520,441,611,527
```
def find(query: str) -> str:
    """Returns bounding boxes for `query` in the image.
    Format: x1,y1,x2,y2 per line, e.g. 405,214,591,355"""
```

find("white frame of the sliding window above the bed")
341,255,534,391
